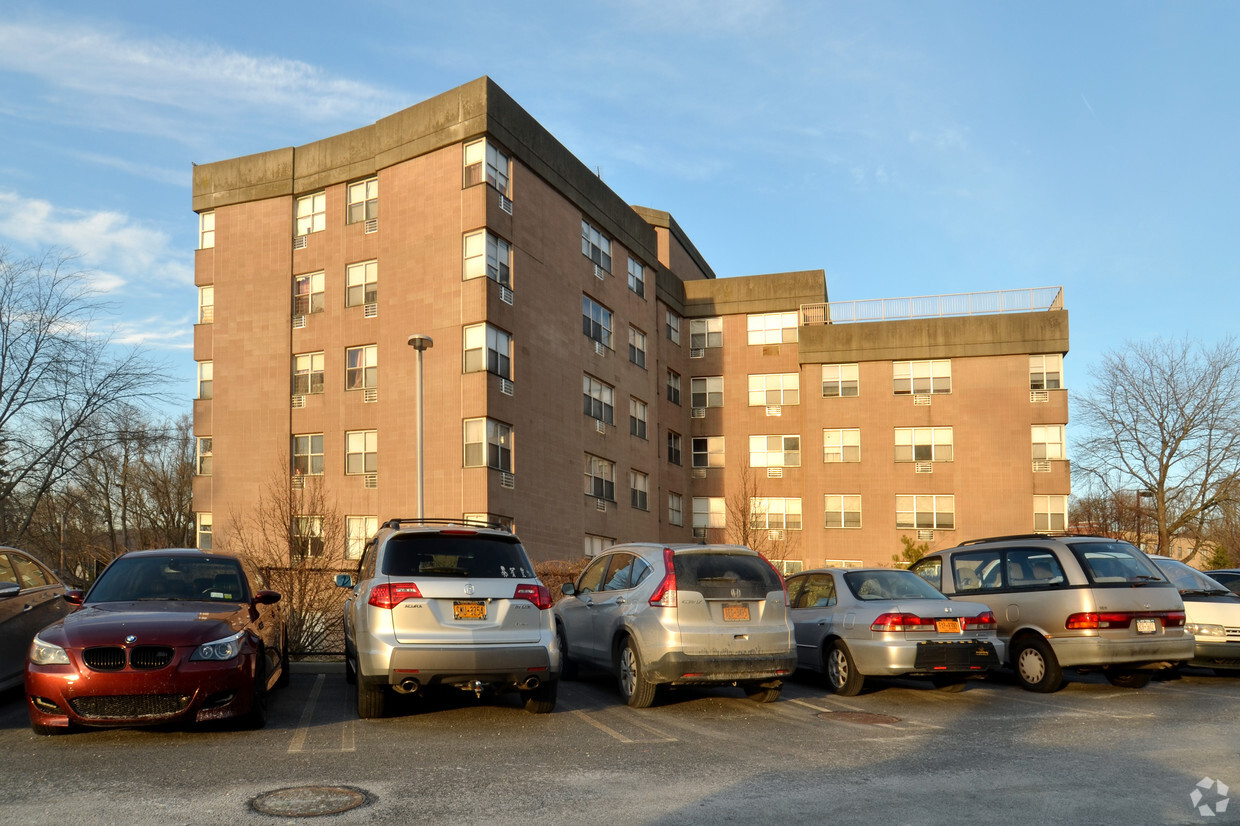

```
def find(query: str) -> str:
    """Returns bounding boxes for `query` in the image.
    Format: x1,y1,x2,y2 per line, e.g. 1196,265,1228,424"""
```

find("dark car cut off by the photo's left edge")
0,547,71,691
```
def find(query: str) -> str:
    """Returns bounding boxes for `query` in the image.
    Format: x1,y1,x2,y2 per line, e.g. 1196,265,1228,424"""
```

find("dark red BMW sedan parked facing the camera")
26,548,289,734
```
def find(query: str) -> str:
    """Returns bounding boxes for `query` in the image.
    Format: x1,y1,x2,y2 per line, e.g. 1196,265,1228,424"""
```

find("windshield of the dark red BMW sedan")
84,556,249,604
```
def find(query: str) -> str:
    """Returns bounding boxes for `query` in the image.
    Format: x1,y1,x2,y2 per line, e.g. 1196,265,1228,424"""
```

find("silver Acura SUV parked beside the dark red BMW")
336,520,560,717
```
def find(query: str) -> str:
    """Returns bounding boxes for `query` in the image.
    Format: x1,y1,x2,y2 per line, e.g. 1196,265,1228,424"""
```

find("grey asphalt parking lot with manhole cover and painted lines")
0,664,1240,825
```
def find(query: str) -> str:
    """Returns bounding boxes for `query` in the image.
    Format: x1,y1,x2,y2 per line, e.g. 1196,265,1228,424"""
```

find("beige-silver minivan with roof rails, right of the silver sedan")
911,533,1193,692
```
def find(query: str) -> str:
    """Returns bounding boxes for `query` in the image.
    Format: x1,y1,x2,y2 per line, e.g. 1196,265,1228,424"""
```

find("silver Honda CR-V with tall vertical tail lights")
554,543,796,708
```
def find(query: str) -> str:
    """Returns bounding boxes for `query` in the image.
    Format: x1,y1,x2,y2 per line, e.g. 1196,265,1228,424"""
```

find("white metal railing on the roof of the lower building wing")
801,286,1064,325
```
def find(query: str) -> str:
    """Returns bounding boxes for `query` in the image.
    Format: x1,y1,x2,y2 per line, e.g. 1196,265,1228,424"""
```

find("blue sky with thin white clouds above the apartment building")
0,0,1240,412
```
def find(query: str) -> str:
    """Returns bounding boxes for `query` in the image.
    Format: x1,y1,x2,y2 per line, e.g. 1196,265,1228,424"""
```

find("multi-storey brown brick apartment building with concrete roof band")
193,78,1069,568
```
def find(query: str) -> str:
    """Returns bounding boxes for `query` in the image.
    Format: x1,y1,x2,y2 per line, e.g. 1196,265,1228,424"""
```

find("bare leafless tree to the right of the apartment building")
1074,339,1240,559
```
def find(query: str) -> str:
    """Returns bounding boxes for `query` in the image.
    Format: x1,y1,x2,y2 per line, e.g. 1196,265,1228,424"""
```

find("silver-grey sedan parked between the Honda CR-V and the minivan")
787,568,1003,697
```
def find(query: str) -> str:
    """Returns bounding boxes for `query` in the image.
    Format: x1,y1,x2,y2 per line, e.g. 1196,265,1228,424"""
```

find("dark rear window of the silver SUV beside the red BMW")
382,533,534,579
